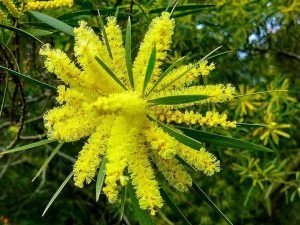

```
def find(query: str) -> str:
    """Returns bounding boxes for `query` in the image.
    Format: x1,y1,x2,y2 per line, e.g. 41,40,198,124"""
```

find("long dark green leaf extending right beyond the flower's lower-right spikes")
177,127,273,152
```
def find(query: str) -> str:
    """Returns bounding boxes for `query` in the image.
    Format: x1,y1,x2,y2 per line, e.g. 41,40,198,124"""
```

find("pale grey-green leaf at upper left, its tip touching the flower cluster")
29,11,74,36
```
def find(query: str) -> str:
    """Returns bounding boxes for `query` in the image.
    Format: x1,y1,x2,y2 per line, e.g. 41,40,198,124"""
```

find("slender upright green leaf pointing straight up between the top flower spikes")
125,17,134,88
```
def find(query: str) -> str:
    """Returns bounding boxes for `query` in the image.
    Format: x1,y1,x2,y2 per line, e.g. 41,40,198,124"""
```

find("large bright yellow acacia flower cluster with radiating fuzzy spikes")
40,12,235,214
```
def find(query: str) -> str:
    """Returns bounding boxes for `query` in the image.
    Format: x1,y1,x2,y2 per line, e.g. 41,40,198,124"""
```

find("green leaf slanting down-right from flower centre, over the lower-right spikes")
148,116,202,150
